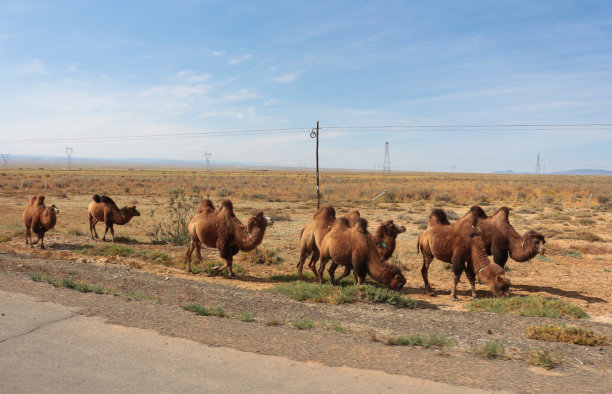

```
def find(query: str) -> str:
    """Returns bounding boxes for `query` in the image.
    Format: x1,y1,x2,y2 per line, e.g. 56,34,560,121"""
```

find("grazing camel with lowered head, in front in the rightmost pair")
417,209,510,300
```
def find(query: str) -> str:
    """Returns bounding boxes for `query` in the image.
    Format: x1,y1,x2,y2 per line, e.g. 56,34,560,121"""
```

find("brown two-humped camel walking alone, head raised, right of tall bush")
183,199,274,277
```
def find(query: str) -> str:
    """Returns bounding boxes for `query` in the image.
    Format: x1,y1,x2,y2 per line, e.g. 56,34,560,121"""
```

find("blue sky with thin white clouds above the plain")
0,0,612,172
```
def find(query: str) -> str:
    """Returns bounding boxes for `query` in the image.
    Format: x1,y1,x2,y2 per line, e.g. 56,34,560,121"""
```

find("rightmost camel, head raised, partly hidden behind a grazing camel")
471,206,546,268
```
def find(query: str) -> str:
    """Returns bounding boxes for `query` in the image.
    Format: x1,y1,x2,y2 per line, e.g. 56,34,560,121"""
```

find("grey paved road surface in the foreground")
0,291,498,394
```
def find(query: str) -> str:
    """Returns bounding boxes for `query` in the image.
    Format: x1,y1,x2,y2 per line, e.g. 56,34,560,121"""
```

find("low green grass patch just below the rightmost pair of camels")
468,296,588,319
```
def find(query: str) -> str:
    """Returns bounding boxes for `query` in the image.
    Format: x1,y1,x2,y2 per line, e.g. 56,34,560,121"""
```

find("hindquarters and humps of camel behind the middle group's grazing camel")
296,205,360,280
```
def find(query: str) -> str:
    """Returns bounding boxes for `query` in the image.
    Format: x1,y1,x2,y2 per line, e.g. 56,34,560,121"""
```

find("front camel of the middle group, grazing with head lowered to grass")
318,218,406,291
